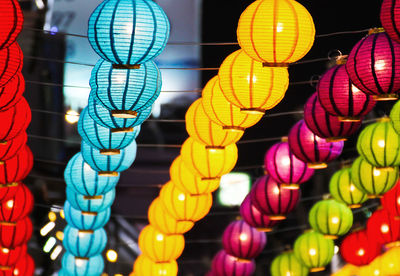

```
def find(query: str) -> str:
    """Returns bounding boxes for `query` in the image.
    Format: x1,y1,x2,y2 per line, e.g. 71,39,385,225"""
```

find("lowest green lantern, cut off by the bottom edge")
271,252,308,276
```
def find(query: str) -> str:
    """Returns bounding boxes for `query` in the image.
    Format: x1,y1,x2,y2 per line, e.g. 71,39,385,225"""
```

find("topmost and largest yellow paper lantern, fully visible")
237,0,315,67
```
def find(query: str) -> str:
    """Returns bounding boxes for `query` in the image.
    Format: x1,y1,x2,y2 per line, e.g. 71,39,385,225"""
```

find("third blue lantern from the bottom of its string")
64,200,111,230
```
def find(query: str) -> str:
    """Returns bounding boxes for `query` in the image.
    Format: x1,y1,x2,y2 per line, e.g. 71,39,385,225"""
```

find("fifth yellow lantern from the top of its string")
181,137,238,180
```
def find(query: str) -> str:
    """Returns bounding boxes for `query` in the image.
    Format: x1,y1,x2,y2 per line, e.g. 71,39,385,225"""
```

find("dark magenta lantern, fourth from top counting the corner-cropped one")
304,93,361,142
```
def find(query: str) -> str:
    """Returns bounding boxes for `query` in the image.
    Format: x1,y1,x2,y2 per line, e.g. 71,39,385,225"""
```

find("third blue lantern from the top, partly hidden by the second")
78,107,139,155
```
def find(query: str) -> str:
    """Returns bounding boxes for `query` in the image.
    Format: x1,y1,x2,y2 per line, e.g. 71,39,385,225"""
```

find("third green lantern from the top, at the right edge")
351,156,399,198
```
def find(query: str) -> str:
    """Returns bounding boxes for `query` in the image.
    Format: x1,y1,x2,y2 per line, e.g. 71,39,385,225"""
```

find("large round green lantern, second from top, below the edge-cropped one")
357,117,400,168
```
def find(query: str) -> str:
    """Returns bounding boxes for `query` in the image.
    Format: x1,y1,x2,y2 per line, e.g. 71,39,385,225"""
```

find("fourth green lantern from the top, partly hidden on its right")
329,168,368,208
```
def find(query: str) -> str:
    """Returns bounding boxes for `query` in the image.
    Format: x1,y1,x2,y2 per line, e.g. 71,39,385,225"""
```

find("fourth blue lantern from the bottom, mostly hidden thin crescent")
66,187,115,213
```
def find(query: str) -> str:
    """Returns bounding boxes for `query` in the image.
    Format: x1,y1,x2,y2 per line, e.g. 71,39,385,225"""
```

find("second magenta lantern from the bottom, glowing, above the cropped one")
222,220,267,260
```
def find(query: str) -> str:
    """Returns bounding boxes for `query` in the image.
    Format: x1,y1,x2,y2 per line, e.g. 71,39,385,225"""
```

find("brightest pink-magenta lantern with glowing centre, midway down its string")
264,142,314,189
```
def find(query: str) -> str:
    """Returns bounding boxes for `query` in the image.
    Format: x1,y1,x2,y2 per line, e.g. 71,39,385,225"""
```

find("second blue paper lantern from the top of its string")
90,59,162,118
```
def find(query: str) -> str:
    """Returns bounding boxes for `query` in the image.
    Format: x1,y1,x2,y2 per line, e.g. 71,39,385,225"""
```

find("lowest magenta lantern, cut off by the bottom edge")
211,250,256,276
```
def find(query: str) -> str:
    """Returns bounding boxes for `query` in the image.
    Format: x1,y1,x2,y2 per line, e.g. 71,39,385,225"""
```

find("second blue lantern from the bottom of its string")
63,225,107,258
